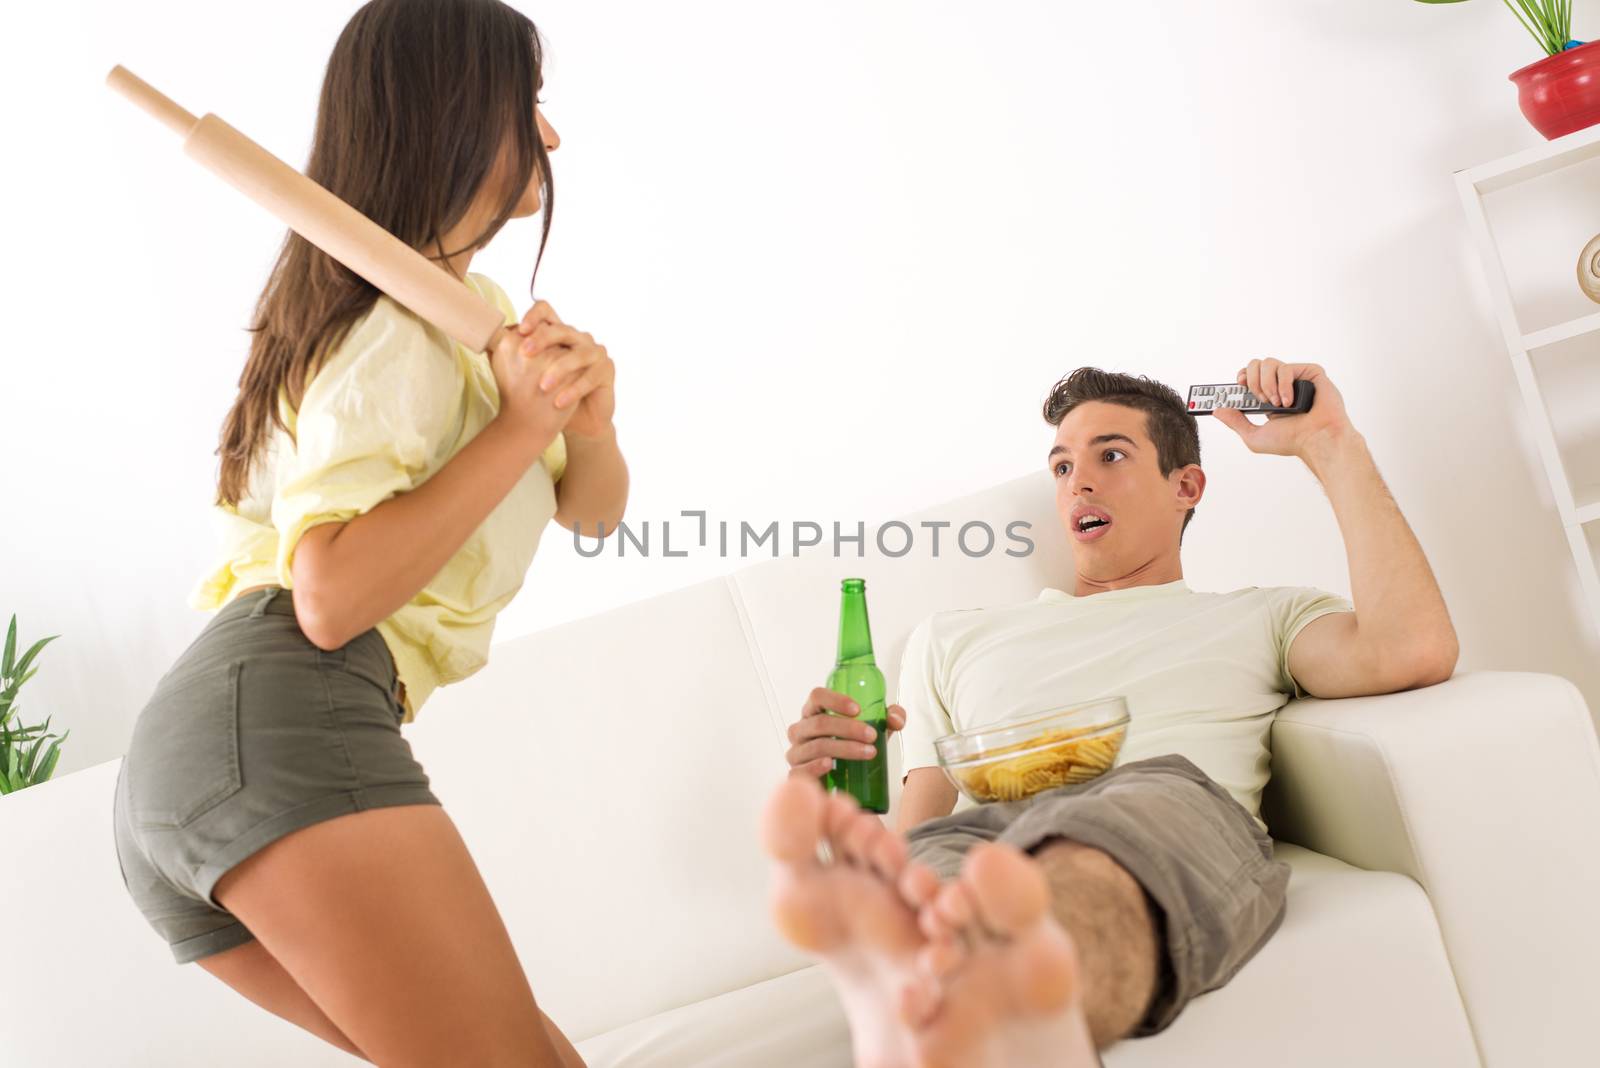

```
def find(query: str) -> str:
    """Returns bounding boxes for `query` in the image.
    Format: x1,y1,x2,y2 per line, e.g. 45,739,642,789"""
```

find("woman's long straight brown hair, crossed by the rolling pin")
216,0,555,507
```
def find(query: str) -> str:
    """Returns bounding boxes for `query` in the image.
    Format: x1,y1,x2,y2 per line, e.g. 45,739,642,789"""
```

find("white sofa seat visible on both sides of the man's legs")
579,844,1478,1068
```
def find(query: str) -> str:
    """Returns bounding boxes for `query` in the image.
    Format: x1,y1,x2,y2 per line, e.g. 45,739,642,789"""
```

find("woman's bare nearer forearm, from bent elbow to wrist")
290,416,555,649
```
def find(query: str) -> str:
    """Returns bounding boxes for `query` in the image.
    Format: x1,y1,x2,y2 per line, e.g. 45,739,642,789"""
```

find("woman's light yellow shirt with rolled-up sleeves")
189,273,566,723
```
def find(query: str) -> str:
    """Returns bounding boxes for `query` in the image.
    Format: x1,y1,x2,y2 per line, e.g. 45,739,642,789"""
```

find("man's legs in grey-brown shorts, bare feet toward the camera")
763,756,1288,1068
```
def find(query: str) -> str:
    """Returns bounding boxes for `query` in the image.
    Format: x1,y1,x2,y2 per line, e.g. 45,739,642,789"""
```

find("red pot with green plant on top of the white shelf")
1419,0,1600,141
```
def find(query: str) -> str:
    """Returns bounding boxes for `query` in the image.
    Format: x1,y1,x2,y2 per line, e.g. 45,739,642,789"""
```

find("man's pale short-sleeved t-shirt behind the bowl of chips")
896,579,1355,822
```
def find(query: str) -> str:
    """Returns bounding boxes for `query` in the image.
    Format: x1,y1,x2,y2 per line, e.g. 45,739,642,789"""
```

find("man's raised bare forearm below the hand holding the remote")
1302,430,1459,665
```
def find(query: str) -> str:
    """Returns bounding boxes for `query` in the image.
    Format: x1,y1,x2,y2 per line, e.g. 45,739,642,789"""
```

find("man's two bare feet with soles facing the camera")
762,779,1098,1068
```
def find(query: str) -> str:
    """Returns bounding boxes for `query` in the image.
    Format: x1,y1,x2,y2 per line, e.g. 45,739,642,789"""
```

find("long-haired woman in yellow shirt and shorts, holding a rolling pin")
115,0,627,1068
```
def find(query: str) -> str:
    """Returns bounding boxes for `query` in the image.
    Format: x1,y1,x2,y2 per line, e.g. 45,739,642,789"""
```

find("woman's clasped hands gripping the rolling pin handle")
490,301,616,451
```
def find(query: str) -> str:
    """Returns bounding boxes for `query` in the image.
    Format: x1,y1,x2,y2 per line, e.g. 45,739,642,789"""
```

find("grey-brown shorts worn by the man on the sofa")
907,755,1290,1034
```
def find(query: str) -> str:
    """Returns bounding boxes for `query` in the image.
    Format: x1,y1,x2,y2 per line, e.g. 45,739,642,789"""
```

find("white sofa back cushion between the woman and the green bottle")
406,579,808,1038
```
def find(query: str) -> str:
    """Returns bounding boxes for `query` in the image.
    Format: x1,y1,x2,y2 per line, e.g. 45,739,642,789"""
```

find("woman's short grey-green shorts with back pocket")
112,587,438,964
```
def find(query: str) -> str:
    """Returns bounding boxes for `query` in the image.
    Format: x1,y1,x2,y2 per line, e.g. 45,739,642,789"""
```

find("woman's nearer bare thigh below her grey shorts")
214,804,582,1068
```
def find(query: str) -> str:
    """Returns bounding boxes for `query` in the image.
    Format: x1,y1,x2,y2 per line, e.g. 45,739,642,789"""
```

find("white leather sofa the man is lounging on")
0,473,1600,1068
